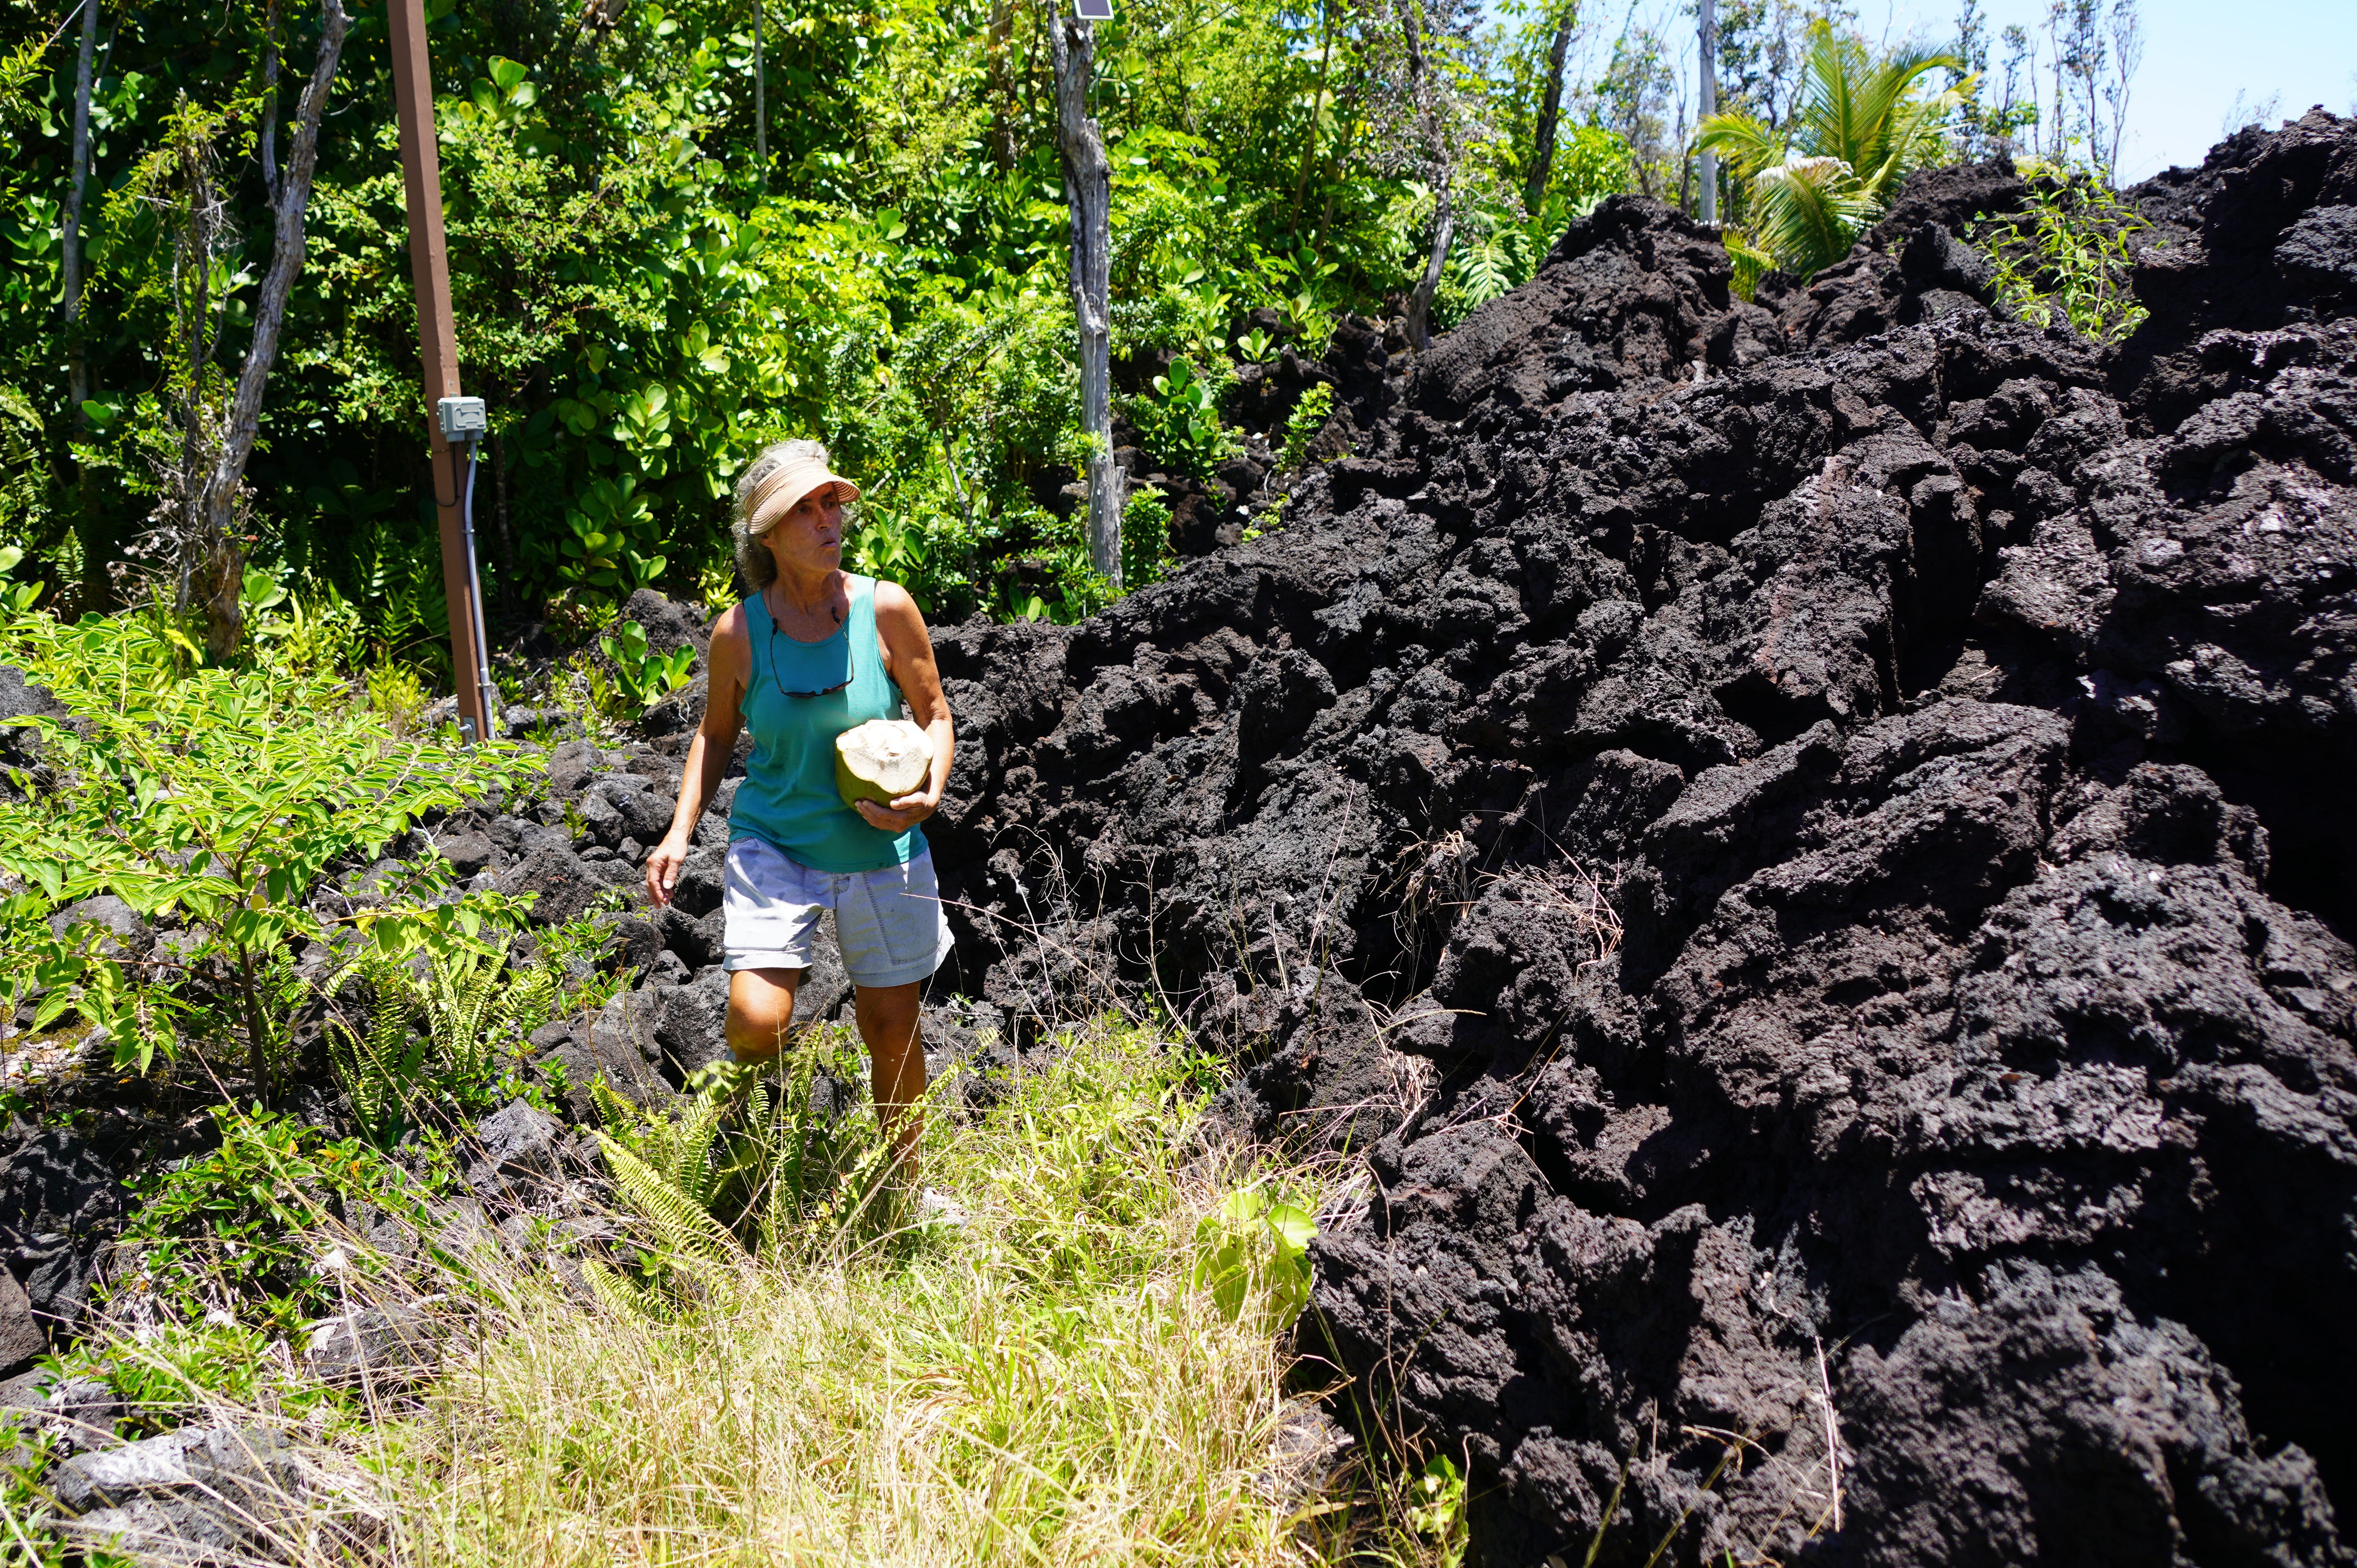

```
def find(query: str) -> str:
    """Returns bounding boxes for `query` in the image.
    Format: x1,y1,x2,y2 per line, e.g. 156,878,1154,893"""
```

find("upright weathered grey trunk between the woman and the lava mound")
1049,17,1122,587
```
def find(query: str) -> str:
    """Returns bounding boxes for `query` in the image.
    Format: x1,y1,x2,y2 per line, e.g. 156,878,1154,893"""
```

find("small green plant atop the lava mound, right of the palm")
1973,177,2152,342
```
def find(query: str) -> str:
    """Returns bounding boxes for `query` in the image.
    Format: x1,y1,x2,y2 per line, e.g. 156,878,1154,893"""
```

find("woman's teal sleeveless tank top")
728,573,924,873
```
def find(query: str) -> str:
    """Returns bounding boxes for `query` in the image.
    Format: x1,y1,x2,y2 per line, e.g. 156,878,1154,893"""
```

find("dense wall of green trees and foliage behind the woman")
0,0,1633,655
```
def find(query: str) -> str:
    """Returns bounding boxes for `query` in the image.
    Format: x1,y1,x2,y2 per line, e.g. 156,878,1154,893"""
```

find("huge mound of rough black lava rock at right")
931,111,2357,1568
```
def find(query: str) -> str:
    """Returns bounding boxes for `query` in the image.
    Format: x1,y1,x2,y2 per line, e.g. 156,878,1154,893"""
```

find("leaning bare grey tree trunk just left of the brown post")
181,0,346,658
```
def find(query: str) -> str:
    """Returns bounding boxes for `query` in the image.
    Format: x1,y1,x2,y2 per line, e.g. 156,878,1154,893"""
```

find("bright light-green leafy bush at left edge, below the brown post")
0,613,537,1097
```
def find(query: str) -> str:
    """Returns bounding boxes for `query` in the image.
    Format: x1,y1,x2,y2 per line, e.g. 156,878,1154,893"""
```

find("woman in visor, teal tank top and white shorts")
646,441,955,1181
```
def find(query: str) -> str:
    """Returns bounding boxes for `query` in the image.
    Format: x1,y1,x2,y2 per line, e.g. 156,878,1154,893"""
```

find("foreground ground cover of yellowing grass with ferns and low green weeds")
19,1021,1464,1566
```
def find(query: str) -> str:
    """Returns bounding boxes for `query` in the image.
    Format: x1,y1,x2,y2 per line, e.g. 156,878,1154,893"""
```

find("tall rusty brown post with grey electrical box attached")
387,0,490,735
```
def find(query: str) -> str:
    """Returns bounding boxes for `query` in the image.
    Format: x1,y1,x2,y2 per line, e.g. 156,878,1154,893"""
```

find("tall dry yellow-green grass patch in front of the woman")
372,1028,1353,1568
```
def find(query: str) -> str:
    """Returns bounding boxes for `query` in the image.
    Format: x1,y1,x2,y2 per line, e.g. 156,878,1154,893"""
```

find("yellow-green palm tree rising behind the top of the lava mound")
1695,21,1973,281
